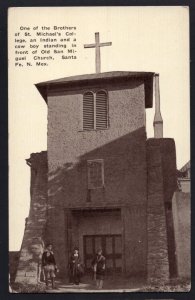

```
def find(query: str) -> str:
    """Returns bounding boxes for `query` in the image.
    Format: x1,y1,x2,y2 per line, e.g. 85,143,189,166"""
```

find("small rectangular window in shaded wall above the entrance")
87,159,104,189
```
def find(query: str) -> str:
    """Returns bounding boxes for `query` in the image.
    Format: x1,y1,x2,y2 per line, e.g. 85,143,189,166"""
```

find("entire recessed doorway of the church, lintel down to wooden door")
69,208,124,276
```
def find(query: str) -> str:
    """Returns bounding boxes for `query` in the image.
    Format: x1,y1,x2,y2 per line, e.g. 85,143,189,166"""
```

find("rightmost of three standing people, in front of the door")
92,249,106,289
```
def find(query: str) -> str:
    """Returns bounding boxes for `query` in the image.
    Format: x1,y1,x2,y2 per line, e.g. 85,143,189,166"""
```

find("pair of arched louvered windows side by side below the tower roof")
83,91,108,130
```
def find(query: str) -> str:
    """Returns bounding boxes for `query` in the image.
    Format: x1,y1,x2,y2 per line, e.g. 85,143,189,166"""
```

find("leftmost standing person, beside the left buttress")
42,244,57,289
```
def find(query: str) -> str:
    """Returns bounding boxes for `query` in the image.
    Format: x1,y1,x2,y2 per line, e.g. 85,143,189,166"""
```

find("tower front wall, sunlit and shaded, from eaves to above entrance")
48,80,146,211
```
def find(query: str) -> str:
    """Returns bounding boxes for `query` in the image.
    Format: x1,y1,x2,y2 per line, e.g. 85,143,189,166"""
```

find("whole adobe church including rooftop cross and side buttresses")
16,34,177,283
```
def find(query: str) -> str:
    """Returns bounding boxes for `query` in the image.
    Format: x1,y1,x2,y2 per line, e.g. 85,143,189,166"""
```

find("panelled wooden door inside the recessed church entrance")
83,234,122,274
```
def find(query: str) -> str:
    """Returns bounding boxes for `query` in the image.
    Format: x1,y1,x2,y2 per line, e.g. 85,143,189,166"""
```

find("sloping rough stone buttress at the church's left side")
15,152,47,284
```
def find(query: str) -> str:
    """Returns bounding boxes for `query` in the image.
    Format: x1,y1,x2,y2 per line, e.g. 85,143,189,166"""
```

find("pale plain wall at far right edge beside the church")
172,192,191,278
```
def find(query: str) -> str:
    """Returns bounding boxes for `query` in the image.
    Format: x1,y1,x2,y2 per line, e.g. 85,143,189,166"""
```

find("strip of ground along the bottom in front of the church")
10,277,191,293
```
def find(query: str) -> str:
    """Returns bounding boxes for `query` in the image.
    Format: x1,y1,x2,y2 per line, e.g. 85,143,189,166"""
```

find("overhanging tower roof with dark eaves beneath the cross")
35,71,155,108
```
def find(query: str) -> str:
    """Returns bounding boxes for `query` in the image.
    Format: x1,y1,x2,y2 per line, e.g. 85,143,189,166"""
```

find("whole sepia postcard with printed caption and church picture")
8,6,191,293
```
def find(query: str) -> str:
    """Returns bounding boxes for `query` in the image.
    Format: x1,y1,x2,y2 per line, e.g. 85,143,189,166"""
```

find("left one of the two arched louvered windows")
83,92,94,130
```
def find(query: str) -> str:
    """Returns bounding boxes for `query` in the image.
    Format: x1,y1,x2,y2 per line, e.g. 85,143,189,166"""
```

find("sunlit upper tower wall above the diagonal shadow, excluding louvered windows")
47,79,145,172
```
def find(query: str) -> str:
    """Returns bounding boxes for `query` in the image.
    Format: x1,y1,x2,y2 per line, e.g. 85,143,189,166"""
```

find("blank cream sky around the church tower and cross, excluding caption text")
8,6,190,251
